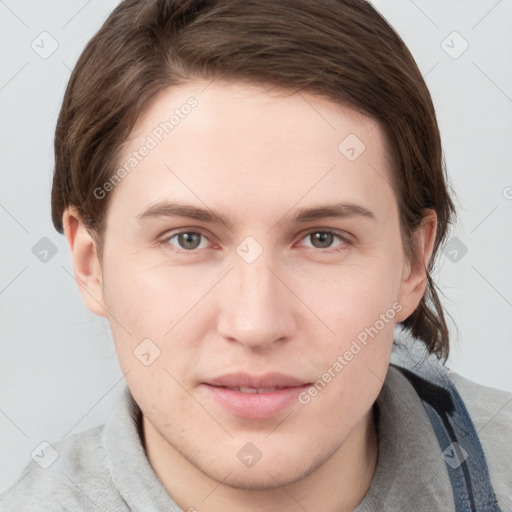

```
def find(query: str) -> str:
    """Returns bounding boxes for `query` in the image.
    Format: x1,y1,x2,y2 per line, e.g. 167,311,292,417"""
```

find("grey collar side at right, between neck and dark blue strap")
354,366,454,512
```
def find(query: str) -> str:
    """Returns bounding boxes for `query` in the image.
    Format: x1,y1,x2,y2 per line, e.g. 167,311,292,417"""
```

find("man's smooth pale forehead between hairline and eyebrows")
107,81,394,228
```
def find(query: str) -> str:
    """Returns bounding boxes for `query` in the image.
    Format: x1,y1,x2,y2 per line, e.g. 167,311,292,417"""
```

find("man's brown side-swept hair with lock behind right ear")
52,0,455,359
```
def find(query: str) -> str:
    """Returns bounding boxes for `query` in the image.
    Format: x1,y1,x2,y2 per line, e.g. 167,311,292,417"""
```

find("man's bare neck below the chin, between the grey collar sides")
142,408,378,512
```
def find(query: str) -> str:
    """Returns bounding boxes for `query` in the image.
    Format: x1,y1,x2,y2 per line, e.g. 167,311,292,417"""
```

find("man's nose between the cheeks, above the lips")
217,252,299,350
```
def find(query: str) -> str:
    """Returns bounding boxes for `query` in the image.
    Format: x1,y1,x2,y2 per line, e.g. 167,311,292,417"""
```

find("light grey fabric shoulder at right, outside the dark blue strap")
447,368,512,510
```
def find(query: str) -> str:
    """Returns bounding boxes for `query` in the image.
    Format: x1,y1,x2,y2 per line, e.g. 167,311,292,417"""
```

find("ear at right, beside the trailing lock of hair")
396,209,437,323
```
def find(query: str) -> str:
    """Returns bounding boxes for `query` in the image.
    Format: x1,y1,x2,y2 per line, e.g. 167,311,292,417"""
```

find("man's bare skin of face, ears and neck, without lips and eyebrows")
63,81,436,512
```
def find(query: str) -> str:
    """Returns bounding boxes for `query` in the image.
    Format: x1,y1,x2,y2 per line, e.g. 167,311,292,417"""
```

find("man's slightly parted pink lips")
200,373,311,419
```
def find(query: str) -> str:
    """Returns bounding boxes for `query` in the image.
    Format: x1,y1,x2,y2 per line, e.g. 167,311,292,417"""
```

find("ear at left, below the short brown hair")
62,207,107,317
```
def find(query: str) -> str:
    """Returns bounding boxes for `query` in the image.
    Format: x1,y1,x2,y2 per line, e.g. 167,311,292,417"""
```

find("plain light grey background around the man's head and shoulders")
0,0,512,492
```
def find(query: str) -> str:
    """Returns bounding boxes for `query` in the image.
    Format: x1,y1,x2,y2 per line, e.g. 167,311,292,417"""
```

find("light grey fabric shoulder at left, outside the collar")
0,426,128,512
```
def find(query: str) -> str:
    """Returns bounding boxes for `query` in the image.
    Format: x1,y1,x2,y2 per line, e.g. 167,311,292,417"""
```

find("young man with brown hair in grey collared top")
0,0,511,512
